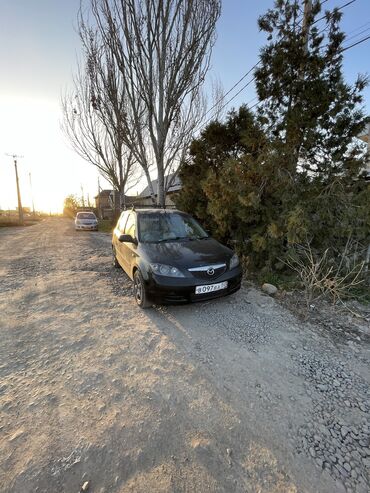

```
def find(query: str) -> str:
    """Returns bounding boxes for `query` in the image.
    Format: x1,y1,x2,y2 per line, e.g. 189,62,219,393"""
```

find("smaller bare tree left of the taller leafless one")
62,16,141,206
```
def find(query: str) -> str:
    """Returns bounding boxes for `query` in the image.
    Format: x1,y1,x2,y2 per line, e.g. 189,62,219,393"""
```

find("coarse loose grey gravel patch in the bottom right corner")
293,354,370,493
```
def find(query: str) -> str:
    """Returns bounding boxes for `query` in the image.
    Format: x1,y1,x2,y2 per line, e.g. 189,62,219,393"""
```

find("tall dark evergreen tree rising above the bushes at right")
255,0,367,180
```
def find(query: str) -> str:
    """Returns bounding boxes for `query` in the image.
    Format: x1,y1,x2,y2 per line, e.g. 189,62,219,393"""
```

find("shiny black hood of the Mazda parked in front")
140,238,234,268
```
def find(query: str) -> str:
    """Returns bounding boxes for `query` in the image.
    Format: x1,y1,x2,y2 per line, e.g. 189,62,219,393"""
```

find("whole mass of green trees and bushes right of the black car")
176,1,370,304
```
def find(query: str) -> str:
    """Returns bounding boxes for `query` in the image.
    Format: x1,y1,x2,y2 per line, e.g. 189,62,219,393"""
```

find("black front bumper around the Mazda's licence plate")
146,266,243,304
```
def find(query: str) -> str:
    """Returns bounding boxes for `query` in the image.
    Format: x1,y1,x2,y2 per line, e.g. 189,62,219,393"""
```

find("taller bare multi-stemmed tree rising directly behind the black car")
86,0,221,205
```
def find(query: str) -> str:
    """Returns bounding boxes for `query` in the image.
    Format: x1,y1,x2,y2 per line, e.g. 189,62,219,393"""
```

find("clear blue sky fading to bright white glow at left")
0,0,370,212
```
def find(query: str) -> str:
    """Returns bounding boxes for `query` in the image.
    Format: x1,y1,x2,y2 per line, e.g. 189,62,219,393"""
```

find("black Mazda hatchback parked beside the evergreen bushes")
112,209,242,308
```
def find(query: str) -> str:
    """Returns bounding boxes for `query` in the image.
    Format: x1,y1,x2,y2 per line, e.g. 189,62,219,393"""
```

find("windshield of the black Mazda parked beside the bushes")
138,212,208,243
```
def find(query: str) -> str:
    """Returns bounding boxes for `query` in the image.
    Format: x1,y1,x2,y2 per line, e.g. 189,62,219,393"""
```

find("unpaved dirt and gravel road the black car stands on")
0,219,370,493
